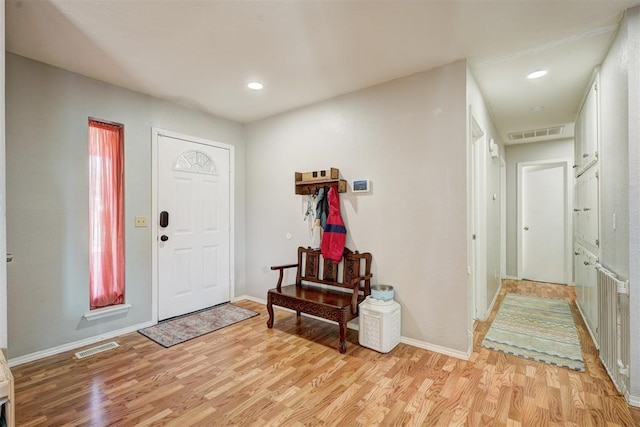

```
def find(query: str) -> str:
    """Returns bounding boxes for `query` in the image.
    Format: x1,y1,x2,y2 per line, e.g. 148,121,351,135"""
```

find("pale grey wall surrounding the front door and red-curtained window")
6,54,245,358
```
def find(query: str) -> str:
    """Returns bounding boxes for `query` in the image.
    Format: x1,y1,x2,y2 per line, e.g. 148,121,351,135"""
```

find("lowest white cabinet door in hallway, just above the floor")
573,245,598,342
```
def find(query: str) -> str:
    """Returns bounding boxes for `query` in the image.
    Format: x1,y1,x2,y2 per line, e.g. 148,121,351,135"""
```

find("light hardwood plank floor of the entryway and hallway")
12,281,640,427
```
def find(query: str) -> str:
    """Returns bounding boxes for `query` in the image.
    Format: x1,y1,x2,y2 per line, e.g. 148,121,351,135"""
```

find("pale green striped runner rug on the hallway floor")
482,294,584,372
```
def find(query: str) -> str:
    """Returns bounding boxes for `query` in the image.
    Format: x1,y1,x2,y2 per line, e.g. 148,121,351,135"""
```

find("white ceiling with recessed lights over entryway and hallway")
5,0,640,142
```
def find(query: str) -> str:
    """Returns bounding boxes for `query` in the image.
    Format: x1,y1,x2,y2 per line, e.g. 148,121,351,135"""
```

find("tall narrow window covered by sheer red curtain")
89,119,124,310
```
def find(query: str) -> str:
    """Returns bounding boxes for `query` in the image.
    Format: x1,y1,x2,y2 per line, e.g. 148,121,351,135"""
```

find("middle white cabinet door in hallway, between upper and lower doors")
573,167,600,253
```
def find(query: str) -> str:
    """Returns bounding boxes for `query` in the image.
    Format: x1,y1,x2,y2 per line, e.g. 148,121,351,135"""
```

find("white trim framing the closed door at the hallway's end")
516,158,573,283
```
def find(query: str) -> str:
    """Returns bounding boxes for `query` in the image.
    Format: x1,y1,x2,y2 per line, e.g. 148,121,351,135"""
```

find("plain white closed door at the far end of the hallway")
519,162,568,284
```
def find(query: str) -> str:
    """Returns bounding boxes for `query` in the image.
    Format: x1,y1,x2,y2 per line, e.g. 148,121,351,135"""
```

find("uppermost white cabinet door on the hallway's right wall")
575,76,600,176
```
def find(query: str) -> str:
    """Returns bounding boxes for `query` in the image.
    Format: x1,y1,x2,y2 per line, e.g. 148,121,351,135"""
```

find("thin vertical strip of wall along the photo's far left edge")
0,0,7,349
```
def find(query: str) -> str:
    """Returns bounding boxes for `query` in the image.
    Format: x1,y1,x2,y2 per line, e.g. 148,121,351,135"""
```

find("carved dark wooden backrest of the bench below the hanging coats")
296,247,371,295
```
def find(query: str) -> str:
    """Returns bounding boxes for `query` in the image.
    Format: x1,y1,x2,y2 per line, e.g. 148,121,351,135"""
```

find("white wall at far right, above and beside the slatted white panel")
600,7,640,406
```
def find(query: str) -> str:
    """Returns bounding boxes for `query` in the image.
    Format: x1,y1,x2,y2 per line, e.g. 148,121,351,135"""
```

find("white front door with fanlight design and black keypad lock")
157,135,230,320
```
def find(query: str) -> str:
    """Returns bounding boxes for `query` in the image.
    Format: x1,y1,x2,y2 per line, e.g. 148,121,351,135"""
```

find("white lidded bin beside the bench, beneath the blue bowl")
358,296,401,353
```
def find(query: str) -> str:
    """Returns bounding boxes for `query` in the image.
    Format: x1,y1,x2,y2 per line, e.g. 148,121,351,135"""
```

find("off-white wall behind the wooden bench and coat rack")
246,61,470,354
